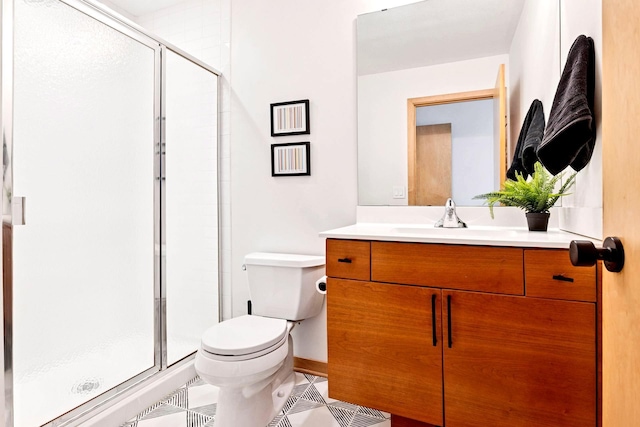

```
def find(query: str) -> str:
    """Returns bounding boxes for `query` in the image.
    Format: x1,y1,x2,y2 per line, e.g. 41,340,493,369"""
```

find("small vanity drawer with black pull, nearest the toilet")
326,239,371,280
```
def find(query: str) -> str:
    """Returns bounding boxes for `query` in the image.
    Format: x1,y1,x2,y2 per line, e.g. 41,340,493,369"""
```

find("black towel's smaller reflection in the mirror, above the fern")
507,99,544,180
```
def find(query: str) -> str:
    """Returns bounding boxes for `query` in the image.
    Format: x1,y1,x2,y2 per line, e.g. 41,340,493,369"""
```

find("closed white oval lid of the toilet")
202,315,287,356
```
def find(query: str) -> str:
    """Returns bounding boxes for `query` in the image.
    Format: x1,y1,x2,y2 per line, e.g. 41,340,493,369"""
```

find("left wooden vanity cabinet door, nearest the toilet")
327,278,443,426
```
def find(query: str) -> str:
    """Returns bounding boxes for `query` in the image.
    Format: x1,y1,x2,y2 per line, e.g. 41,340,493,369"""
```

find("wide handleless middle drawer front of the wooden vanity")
371,242,524,295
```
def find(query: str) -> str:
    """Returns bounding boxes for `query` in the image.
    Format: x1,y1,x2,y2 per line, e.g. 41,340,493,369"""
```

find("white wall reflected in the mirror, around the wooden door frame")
357,55,509,205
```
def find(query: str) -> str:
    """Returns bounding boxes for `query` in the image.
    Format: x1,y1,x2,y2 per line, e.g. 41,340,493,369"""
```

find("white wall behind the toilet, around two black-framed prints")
231,0,424,361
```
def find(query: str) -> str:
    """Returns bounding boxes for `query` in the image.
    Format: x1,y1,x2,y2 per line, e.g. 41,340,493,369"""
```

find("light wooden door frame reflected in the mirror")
407,88,505,206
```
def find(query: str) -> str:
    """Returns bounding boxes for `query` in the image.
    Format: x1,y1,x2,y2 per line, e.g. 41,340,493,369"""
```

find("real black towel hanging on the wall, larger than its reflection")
537,35,596,175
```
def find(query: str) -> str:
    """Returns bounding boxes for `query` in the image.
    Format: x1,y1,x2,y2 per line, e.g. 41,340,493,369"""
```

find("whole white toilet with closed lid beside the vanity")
195,252,324,427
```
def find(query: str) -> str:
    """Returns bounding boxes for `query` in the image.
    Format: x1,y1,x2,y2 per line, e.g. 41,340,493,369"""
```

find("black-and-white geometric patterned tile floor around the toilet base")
121,372,391,427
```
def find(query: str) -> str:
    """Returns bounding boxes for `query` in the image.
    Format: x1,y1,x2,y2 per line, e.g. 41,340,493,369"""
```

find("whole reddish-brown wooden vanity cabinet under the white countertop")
327,239,598,427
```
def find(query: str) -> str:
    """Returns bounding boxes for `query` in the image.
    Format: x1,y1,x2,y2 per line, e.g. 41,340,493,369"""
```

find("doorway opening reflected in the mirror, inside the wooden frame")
408,98,500,206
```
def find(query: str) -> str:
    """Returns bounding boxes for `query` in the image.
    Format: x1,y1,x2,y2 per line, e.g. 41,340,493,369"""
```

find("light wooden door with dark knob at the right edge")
602,0,640,427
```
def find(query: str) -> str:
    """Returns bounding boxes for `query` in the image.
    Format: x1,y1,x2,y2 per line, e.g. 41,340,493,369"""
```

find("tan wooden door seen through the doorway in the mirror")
413,123,452,206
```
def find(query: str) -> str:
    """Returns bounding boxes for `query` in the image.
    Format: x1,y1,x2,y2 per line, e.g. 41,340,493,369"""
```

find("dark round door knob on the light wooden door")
569,237,624,273
